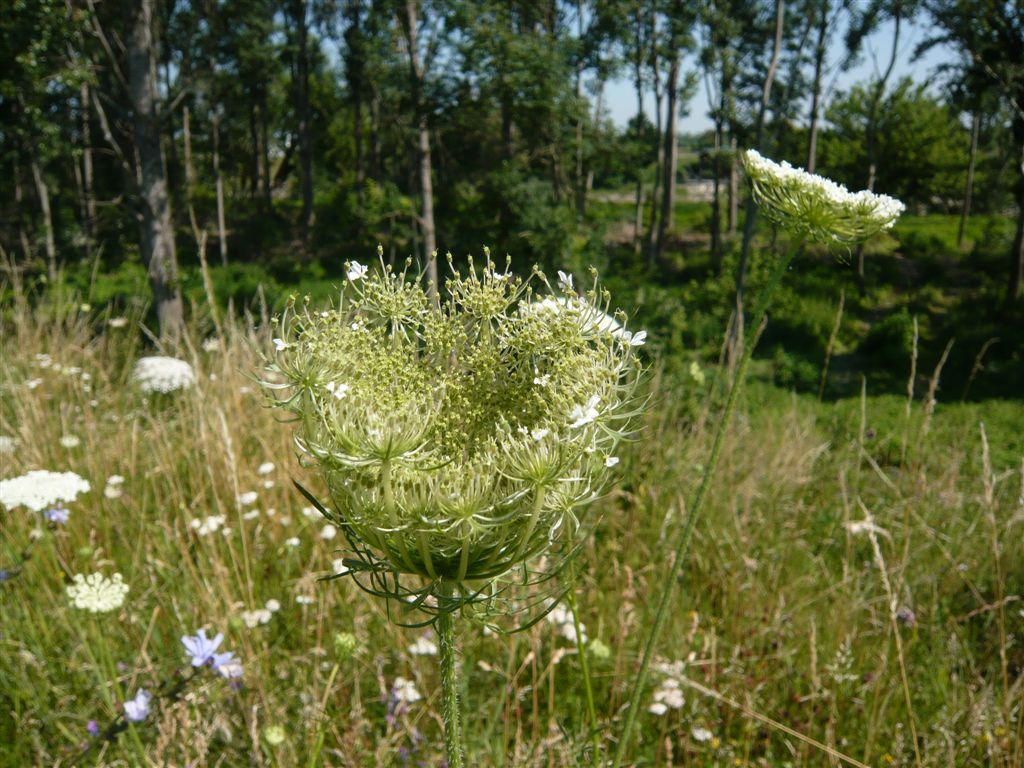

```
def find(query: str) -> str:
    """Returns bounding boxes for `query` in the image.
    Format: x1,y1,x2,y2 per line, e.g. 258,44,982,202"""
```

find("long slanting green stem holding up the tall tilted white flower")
611,238,804,768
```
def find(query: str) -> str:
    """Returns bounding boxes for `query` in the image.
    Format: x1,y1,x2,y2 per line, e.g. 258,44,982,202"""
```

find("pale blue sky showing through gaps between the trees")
605,16,955,133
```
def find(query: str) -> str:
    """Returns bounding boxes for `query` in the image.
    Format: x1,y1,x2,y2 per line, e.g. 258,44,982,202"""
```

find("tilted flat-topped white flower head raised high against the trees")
743,150,905,245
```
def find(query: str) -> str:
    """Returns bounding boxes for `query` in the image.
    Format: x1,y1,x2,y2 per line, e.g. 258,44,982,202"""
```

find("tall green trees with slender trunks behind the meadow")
0,0,1024,333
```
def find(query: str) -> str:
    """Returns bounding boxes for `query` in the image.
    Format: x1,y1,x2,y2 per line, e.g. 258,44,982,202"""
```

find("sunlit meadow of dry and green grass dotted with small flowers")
0,218,1024,768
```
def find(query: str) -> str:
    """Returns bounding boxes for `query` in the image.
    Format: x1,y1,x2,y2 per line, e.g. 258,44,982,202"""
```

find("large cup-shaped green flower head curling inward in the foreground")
268,254,646,608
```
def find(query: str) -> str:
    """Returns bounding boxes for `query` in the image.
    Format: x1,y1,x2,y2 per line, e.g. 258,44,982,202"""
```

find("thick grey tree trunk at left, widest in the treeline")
126,0,184,342
